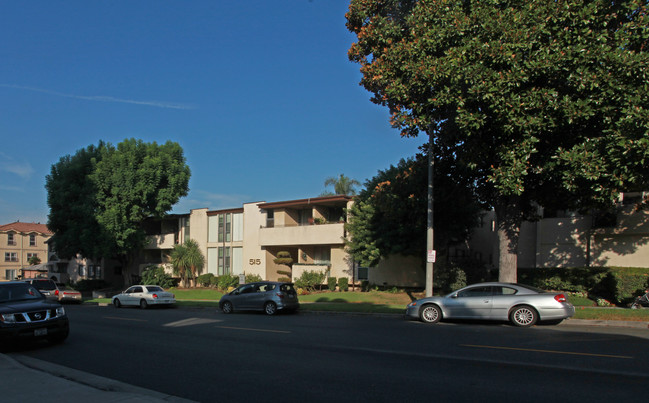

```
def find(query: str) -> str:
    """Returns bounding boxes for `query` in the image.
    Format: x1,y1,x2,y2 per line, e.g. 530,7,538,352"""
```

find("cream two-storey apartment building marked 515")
138,196,353,280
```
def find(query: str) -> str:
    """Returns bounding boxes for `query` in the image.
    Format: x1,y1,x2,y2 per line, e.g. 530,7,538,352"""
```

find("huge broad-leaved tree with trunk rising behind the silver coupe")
347,0,649,281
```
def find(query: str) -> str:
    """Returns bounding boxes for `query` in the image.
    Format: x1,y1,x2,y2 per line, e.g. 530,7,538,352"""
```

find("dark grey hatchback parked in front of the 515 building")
219,281,300,315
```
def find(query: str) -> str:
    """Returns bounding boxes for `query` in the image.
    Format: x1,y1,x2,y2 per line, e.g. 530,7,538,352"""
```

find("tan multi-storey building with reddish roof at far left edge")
0,221,53,281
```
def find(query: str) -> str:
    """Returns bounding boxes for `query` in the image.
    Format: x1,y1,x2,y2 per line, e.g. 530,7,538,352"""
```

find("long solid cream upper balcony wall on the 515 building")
259,223,345,246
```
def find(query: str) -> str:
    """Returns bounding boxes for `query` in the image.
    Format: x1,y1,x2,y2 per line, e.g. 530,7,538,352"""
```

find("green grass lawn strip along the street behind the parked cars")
86,288,649,322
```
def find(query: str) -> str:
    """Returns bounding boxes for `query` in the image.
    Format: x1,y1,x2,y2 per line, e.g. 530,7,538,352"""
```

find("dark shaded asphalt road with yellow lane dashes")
9,306,649,402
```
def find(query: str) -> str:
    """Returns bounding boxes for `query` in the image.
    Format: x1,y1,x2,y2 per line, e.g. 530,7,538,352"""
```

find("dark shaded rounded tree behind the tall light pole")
345,150,481,269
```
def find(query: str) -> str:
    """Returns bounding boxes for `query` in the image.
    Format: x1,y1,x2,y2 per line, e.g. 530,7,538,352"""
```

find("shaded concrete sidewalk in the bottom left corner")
0,354,192,403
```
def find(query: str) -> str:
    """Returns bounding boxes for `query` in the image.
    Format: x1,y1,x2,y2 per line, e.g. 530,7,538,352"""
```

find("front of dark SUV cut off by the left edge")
0,281,70,343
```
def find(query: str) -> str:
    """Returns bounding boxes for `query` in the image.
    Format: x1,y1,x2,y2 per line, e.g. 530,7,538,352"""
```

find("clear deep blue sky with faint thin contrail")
0,0,425,224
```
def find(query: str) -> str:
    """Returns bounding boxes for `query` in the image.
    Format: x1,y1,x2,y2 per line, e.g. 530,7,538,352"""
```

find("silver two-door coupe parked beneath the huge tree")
406,283,575,327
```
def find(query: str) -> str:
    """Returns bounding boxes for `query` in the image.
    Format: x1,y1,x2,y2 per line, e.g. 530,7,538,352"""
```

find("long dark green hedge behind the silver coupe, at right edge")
518,267,649,305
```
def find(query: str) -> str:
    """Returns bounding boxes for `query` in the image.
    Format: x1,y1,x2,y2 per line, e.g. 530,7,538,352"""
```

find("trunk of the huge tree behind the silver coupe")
496,196,523,283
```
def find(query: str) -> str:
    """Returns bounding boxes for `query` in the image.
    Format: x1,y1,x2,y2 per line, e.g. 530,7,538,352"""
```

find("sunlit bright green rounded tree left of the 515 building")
90,139,190,281
